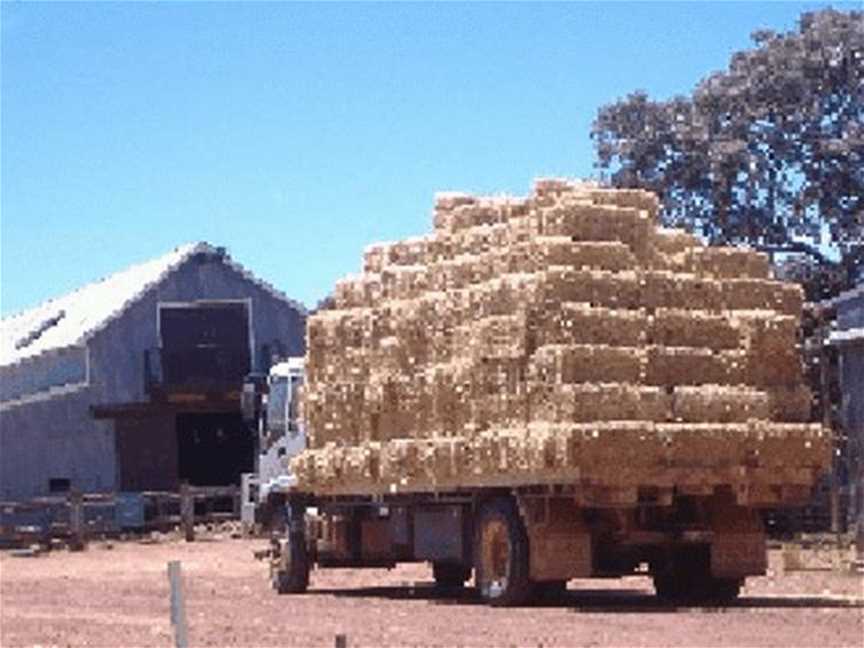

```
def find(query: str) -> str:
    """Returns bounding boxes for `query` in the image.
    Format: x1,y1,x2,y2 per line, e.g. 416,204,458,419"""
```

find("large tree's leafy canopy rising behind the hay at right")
592,9,864,298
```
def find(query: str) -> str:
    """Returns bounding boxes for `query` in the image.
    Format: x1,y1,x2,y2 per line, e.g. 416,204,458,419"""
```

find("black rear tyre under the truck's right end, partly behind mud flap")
654,547,743,605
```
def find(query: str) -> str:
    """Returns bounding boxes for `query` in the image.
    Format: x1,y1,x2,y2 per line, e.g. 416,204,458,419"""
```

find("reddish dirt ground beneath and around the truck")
0,538,864,648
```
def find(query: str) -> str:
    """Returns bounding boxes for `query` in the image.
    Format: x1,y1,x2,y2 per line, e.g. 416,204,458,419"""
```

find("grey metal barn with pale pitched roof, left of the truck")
0,243,306,501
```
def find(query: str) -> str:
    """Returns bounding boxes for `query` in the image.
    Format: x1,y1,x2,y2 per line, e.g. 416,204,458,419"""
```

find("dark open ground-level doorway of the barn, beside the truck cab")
177,412,255,486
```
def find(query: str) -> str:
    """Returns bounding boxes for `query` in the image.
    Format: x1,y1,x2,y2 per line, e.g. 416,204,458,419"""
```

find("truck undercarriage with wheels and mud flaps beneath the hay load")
270,485,767,606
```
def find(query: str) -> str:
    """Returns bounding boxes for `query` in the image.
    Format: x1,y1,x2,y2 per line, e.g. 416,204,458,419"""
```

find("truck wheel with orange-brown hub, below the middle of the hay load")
474,498,533,605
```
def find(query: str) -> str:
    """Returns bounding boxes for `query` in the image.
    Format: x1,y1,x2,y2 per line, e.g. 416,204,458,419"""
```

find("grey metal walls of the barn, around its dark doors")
0,253,305,500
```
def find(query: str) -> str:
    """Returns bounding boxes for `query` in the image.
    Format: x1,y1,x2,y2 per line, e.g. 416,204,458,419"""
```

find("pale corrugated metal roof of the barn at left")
0,242,306,366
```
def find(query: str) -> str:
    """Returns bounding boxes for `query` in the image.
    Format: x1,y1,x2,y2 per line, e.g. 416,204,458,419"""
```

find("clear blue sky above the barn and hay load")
0,2,854,316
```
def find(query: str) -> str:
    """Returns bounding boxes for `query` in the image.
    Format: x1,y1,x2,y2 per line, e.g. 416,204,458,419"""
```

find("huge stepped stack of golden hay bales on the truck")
291,180,821,493
